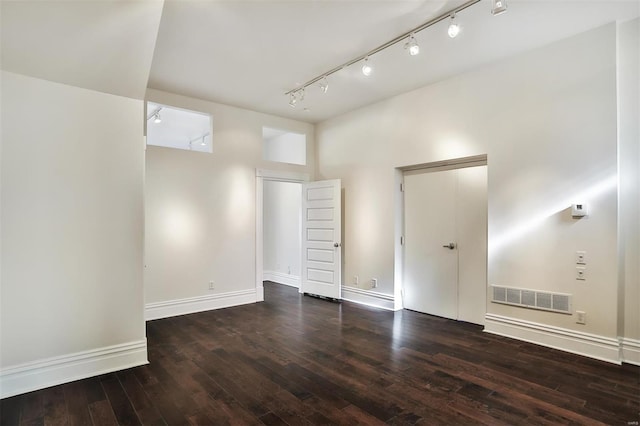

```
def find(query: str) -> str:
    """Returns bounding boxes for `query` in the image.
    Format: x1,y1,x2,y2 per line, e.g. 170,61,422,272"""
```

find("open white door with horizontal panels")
301,179,342,299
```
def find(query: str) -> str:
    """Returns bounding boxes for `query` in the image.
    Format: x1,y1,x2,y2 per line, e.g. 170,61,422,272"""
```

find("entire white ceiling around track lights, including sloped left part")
1,0,640,122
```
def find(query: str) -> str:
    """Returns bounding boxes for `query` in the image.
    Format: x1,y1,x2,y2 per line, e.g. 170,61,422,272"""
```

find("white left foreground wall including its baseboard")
0,72,147,396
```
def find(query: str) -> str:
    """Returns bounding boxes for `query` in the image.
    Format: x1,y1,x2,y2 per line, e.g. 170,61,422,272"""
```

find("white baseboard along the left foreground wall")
0,339,149,398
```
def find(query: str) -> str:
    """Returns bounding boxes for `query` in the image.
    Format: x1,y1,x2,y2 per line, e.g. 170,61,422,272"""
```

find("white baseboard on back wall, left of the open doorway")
144,288,257,321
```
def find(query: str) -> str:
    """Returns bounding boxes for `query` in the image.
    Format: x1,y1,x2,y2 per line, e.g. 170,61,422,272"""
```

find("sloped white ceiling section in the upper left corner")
0,0,163,99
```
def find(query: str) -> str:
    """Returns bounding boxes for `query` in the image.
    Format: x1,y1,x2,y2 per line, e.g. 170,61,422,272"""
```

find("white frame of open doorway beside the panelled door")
256,169,310,302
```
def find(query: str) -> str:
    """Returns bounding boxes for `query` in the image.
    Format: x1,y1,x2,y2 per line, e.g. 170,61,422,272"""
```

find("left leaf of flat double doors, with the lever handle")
403,170,458,319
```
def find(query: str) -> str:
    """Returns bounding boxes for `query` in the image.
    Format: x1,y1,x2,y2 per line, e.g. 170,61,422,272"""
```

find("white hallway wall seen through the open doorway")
263,181,302,284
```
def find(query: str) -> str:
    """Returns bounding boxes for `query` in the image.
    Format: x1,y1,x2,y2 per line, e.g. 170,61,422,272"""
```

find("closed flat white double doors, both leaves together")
403,166,487,324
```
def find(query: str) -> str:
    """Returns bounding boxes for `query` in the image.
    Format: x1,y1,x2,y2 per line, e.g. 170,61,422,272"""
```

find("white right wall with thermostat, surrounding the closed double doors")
316,24,618,360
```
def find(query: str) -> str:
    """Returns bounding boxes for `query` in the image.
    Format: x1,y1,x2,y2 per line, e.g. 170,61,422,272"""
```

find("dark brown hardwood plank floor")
0,283,640,426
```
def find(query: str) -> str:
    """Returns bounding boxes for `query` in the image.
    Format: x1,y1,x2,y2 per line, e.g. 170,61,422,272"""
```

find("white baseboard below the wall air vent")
484,314,621,364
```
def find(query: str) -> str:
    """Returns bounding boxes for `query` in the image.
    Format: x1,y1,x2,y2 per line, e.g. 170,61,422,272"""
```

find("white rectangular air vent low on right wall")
491,285,571,314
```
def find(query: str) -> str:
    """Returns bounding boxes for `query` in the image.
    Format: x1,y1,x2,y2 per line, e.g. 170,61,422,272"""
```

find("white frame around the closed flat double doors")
393,154,488,311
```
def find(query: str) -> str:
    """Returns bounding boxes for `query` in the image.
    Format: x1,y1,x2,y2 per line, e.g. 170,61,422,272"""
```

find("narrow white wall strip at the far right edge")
618,19,640,350
